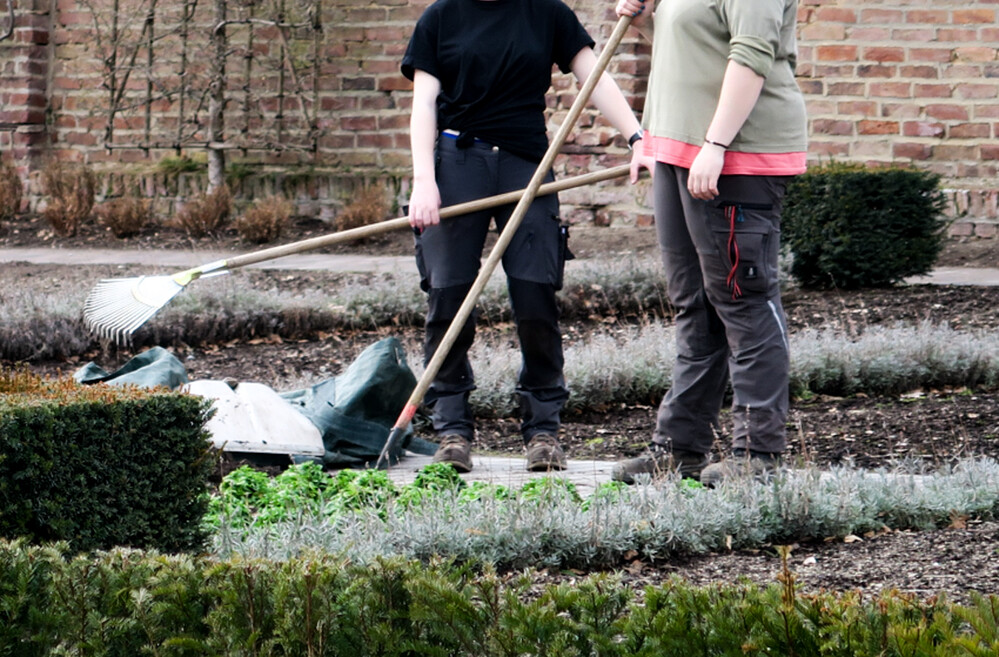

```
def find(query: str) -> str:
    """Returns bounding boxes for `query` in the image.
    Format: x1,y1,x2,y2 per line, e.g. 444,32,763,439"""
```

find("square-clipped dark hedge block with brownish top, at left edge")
0,369,214,551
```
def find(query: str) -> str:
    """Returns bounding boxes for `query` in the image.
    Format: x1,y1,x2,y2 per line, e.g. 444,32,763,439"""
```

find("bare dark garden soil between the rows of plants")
0,213,999,600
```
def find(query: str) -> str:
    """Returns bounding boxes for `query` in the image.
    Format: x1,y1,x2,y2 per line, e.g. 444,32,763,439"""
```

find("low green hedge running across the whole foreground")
0,542,999,657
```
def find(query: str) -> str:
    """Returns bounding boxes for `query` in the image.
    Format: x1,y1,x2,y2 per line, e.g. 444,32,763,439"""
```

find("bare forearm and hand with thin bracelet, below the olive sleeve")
687,60,764,201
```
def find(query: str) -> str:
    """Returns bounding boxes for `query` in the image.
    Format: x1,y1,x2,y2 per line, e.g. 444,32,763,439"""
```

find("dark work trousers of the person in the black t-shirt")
416,136,569,441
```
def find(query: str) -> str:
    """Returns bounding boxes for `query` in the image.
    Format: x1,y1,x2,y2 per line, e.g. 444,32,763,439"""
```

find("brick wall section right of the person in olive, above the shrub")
798,0,999,237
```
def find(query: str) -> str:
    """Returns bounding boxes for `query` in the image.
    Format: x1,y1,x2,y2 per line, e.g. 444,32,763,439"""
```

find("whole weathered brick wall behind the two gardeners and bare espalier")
0,0,999,236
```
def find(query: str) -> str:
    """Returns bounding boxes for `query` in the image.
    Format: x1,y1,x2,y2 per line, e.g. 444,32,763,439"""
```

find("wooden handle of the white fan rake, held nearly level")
225,164,629,269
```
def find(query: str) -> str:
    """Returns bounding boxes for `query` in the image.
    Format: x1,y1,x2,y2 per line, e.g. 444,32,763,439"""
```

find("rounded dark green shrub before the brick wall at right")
782,163,946,289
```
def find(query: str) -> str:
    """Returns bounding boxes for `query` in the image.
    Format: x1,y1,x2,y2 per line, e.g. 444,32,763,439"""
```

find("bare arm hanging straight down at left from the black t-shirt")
409,69,441,229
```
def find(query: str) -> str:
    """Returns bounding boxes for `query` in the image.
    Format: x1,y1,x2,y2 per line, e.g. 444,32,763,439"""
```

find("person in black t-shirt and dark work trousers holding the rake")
402,0,654,472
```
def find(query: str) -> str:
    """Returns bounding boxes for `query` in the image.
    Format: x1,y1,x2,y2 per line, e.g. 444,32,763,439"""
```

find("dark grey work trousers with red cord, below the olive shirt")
653,163,790,454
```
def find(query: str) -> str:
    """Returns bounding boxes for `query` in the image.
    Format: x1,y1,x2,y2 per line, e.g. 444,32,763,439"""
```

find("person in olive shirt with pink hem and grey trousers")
613,0,807,485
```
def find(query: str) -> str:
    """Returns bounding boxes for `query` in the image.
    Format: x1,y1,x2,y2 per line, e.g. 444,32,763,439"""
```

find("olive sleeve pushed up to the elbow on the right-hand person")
721,0,784,77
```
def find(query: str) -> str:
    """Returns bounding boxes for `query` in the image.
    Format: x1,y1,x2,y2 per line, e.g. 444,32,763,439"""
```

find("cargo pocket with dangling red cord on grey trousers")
714,202,777,299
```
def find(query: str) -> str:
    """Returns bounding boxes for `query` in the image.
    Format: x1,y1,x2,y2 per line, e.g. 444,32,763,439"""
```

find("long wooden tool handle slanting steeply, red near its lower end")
375,16,631,468
